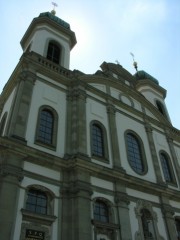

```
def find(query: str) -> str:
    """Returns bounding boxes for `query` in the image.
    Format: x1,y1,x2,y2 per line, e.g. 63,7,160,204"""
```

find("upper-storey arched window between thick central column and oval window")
90,121,108,161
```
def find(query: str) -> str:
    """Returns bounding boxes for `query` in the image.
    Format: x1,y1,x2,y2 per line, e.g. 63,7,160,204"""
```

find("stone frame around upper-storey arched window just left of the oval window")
90,120,109,162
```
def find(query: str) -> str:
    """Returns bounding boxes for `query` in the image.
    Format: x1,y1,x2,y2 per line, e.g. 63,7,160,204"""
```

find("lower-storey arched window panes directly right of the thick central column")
94,200,109,223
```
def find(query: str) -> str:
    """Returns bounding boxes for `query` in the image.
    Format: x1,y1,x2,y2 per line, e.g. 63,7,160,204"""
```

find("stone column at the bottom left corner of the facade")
0,150,23,240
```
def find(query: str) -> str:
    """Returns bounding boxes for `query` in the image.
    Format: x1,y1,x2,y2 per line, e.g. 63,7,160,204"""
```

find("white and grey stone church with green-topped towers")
0,7,180,240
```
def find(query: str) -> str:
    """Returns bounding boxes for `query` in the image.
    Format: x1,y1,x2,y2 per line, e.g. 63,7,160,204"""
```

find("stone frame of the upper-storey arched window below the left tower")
35,105,58,150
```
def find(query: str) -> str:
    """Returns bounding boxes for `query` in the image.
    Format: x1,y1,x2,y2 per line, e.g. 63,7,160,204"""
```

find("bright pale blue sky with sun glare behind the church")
0,0,180,129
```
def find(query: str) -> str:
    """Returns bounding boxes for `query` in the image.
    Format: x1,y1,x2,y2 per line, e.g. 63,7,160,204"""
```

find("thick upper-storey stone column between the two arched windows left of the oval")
66,81,87,157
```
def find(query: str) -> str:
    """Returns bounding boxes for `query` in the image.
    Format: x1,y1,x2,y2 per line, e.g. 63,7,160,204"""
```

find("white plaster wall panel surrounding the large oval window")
116,113,156,182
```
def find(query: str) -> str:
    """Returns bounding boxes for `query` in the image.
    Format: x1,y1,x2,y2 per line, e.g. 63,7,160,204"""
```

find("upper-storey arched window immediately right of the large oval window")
160,151,175,183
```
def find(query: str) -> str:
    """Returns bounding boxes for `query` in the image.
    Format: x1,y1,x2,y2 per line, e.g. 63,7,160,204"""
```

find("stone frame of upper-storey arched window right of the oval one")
159,150,177,186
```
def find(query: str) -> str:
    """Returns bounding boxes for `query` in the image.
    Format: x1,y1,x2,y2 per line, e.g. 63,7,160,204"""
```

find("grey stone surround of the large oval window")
124,130,148,175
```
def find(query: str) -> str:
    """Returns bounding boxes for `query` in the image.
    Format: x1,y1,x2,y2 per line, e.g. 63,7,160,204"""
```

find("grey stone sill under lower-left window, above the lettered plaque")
21,209,57,226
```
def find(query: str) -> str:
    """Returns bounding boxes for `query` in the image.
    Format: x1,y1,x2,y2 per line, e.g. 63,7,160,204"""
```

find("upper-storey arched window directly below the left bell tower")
36,106,58,147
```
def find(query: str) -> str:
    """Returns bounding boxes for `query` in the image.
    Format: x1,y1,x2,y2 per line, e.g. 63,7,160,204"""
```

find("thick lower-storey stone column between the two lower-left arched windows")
61,169,92,240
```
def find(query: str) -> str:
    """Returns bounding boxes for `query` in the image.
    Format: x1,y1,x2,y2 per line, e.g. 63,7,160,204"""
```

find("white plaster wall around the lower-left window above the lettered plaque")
13,177,59,240
